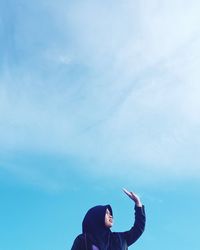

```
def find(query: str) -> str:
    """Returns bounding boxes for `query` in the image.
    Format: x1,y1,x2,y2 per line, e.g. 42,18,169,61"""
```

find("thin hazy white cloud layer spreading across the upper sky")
0,1,200,188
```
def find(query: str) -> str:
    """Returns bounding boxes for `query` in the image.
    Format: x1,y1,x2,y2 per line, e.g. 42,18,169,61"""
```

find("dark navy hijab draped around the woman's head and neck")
82,205,113,250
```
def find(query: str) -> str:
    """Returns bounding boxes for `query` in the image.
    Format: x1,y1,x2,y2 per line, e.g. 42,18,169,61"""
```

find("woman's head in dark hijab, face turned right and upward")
82,205,113,233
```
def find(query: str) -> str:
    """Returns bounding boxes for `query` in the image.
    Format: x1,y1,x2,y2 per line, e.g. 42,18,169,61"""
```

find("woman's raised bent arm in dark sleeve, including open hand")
122,189,146,246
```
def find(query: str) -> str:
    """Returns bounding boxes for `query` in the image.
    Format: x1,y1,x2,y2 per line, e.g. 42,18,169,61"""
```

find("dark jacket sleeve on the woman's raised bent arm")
121,206,146,246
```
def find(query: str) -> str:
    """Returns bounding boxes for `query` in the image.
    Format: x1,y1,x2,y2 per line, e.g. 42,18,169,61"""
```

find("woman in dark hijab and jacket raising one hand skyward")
71,189,146,250
